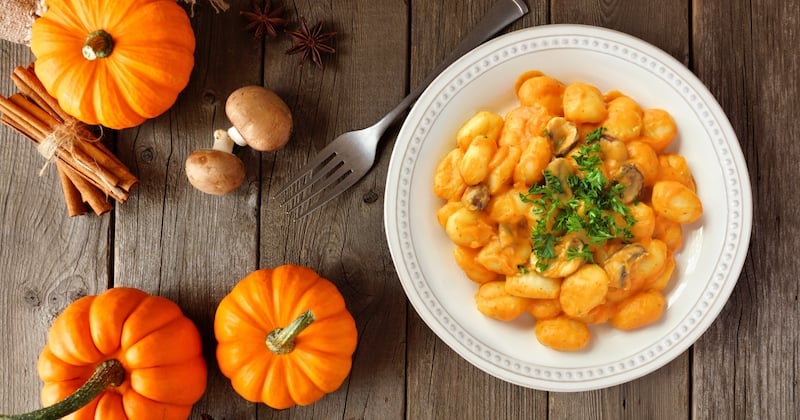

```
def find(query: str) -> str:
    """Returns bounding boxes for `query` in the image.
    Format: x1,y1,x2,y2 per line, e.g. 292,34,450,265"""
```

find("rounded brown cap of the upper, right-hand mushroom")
225,85,293,152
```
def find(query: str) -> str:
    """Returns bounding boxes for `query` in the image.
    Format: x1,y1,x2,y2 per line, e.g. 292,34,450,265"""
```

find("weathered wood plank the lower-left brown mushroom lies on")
114,1,262,419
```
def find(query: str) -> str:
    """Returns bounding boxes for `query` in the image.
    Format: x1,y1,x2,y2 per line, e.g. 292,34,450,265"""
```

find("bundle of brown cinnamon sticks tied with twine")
0,67,138,216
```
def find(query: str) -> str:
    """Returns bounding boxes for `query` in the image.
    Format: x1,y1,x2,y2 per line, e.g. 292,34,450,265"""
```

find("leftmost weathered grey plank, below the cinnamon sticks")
0,41,111,413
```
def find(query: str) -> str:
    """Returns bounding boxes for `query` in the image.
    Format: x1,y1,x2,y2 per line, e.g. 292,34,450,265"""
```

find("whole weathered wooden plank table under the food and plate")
0,0,800,419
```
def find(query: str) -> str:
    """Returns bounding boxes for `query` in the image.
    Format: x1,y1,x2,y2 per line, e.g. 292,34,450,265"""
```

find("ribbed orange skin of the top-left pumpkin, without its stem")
31,0,195,129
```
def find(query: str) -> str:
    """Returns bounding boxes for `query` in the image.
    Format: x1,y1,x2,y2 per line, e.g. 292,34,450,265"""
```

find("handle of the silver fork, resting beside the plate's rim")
374,0,528,133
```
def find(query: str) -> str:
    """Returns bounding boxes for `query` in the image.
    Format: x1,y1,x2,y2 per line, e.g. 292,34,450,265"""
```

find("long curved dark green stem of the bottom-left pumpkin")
0,359,125,420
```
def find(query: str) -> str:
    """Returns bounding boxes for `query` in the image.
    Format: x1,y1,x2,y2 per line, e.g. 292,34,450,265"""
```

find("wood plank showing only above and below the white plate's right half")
550,0,690,419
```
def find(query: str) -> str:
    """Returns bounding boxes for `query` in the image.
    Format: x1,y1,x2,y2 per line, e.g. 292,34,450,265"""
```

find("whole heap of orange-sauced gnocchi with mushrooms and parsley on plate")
433,70,703,351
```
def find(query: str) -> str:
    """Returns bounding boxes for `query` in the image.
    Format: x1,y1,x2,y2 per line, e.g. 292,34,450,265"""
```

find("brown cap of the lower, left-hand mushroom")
186,149,245,195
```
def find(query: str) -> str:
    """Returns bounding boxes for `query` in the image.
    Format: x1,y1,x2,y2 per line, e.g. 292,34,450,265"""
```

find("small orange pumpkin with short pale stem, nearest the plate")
214,265,357,409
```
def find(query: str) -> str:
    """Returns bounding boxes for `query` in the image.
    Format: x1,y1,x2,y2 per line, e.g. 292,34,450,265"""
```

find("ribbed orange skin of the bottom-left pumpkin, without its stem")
37,288,207,420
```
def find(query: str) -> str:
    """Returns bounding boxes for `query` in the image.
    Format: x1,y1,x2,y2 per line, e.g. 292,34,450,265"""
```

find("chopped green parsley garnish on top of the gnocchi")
521,127,636,271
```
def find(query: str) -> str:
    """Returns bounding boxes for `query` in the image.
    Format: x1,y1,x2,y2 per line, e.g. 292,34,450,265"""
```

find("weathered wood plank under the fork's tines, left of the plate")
259,0,408,419
